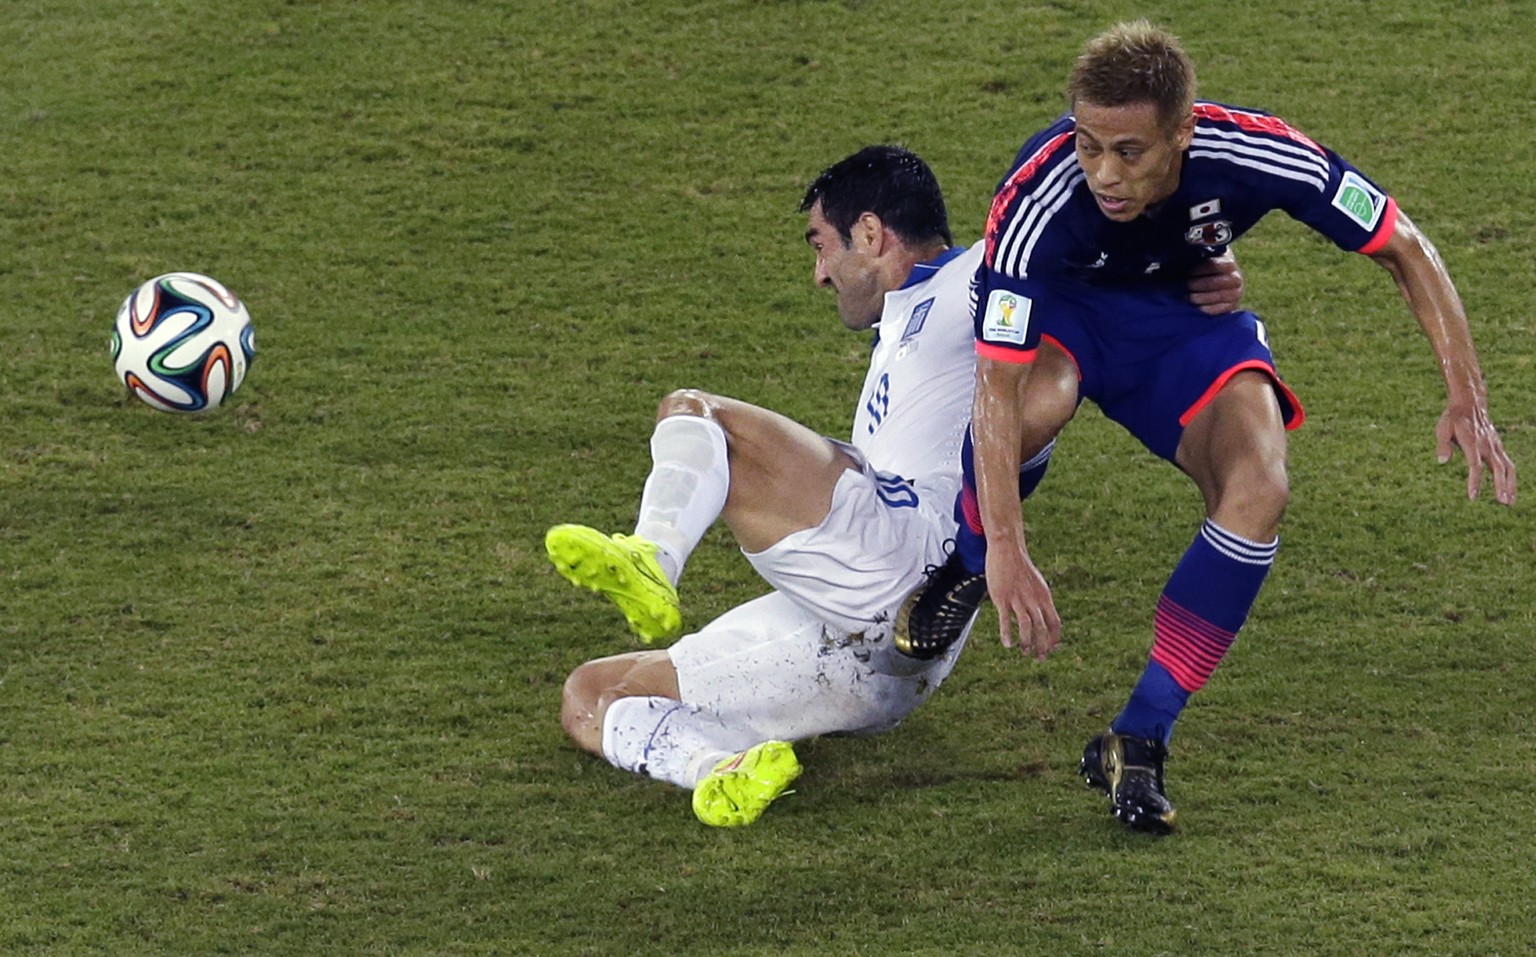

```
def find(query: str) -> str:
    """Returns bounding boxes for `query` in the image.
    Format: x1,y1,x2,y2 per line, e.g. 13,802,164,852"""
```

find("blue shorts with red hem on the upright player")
1031,286,1306,462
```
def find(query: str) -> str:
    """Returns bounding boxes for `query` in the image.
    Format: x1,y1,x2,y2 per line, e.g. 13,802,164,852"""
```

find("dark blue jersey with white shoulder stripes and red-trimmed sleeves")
972,101,1398,363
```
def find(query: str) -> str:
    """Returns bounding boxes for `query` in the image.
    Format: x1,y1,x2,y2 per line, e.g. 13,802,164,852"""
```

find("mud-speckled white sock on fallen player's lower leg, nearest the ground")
602,697,757,791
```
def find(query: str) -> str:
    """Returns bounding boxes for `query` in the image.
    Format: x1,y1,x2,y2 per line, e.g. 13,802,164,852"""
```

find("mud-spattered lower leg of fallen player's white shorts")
667,591,969,740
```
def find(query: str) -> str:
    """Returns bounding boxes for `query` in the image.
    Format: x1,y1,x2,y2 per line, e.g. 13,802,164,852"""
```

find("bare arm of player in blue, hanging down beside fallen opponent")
971,356,1061,657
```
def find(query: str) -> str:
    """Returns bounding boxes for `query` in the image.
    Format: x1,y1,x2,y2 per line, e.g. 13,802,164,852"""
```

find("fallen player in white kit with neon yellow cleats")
545,146,1241,826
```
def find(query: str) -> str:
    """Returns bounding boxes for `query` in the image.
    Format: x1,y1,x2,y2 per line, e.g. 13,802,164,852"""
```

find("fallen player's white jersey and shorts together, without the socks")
670,243,983,750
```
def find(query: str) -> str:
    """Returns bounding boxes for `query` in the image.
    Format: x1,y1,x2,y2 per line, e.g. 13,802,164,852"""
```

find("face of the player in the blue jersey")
1072,101,1195,223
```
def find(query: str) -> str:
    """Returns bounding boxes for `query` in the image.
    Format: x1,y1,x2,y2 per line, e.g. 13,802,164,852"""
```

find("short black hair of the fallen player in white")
800,146,954,246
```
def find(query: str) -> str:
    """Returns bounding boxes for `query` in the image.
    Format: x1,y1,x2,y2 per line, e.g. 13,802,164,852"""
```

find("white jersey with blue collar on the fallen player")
852,243,983,482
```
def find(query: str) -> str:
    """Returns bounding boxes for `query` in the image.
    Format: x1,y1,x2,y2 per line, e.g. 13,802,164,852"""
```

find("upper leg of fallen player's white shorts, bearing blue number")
742,442,960,634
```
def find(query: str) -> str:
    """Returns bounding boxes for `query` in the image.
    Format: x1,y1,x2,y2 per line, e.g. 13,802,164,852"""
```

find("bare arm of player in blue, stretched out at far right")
1372,210,1516,505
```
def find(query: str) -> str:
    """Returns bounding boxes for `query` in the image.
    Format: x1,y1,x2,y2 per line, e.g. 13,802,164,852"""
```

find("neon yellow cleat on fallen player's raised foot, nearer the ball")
544,525,682,645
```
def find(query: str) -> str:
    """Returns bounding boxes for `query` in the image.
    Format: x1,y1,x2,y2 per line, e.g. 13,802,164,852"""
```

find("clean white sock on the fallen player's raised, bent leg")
634,415,731,585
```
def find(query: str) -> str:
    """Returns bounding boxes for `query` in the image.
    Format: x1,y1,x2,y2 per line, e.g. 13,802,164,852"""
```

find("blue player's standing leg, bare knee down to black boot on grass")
1083,370,1289,833
